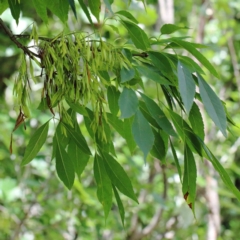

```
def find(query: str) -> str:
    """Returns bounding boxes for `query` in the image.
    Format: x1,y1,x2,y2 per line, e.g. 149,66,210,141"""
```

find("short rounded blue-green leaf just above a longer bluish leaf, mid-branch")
118,87,138,118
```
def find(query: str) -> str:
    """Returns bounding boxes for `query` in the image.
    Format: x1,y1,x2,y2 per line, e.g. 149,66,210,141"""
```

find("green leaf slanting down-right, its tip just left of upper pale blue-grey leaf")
137,65,172,85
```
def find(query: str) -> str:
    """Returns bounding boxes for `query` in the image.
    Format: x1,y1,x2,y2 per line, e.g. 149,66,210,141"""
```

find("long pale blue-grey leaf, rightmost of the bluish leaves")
197,74,227,137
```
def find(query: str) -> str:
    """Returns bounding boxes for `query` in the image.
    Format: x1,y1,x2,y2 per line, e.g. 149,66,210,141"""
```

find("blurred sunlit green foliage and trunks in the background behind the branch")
0,0,240,240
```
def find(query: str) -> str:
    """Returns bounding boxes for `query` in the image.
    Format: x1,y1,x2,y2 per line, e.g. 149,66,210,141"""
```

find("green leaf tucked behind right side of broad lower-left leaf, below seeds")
67,140,89,179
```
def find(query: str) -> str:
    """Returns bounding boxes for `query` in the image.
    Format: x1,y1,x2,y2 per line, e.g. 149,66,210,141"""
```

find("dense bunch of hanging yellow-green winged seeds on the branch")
14,31,131,138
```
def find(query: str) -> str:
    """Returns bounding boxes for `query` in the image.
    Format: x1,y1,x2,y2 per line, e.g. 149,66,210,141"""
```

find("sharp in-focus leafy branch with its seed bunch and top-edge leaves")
0,0,236,227
